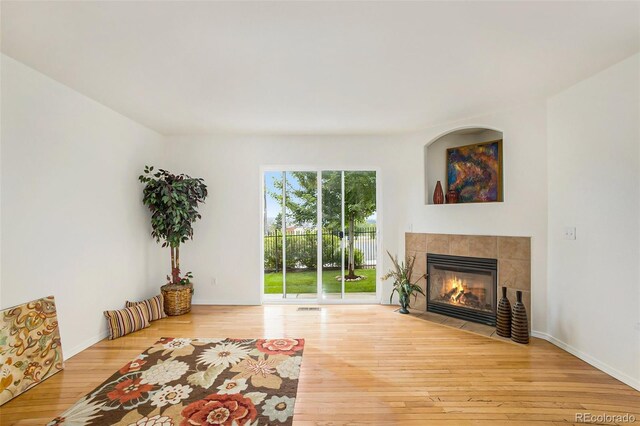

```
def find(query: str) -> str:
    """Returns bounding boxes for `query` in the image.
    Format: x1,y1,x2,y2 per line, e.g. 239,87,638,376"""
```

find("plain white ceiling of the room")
1,1,640,134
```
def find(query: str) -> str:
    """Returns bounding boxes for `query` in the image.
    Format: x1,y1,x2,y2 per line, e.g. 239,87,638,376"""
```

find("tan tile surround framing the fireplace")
405,233,531,331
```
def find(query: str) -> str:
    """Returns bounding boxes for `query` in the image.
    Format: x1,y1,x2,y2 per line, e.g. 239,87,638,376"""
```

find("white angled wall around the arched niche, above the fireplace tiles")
399,100,547,331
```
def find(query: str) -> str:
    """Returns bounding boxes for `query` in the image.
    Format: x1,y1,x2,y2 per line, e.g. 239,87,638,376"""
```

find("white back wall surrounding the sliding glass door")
156,136,410,304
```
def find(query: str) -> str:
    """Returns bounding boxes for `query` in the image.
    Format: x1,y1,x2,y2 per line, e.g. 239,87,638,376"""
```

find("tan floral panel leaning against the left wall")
0,296,63,405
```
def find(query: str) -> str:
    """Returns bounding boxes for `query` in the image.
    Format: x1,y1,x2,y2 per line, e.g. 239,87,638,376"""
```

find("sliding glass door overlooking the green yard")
263,170,378,302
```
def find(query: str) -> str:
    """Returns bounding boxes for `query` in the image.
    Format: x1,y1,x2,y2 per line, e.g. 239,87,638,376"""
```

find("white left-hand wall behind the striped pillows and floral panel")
0,55,162,357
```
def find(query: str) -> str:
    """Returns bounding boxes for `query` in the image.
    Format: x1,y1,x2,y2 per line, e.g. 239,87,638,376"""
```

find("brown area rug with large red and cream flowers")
49,338,304,426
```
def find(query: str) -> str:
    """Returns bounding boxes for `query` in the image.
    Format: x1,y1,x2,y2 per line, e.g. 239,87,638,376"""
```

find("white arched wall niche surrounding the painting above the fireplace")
424,126,504,204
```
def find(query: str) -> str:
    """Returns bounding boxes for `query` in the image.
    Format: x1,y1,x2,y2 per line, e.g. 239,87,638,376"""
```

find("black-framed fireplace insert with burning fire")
427,253,498,326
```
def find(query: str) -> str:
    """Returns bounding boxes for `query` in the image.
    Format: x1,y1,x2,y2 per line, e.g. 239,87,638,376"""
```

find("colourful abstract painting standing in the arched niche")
447,140,502,203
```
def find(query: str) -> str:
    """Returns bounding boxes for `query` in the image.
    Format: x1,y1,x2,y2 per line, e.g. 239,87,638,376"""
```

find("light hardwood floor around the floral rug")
0,305,640,425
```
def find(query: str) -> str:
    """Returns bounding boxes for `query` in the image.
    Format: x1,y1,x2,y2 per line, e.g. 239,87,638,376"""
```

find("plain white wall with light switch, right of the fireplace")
548,55,640,389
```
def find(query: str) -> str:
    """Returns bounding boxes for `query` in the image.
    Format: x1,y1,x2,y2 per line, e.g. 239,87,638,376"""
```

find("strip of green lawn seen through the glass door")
264,269,376,294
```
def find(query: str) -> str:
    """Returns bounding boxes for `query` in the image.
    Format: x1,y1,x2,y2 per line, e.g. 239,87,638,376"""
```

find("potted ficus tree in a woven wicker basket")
138,166,207,315
